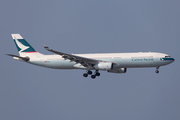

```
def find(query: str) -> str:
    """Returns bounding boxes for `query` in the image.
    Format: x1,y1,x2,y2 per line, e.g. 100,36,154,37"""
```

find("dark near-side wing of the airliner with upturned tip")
44,45,102,68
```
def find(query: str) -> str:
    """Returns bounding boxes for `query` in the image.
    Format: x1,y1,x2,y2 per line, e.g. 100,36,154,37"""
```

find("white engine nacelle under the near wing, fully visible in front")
94,62,113,70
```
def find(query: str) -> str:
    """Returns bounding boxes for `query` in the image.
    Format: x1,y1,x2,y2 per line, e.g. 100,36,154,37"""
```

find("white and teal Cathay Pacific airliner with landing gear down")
6,34,175,79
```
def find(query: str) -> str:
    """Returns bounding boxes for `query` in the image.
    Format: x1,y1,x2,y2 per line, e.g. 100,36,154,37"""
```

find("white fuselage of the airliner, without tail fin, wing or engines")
23,52,174,69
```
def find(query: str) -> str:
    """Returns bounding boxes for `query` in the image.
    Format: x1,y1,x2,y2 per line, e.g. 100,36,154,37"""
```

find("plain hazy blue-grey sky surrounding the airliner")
0,0,180,120
